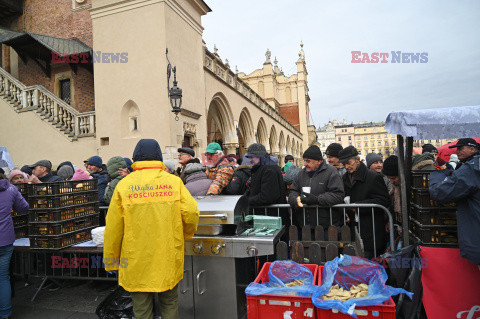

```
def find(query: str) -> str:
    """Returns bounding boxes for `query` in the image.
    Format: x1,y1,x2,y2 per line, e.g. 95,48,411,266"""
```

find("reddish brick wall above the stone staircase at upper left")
12,0,95,112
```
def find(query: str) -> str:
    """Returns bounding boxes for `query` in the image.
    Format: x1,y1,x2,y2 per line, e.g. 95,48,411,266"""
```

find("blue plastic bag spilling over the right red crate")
312,255,413,318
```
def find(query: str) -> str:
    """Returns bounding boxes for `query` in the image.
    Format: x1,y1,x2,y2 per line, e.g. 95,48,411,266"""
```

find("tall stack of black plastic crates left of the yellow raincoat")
28,179,99,249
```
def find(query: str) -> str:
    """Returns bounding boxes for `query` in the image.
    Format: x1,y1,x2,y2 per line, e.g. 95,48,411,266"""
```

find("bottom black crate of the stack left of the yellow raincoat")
29,227,95,250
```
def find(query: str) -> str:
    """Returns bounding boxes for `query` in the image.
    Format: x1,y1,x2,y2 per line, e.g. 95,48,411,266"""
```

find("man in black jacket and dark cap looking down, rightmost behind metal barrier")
338,146,390,258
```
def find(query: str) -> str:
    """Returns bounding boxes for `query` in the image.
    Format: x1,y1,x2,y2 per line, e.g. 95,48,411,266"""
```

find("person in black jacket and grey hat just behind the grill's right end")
246,143,290,225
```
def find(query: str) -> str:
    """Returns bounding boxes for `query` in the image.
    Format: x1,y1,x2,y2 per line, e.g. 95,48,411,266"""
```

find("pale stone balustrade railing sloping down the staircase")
0,68,95,139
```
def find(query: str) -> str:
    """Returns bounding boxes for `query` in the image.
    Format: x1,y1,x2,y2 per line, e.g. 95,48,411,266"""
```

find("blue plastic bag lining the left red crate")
245,260,318,297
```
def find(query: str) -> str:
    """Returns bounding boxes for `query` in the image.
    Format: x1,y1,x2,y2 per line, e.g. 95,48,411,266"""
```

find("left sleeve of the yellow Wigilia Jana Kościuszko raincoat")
103,188,124,271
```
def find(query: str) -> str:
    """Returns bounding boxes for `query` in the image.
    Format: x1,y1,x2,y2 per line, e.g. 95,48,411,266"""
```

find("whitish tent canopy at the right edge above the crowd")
385,105,480,140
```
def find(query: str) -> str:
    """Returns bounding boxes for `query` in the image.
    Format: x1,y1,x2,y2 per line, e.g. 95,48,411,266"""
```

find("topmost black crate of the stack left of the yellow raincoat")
27,179,98,196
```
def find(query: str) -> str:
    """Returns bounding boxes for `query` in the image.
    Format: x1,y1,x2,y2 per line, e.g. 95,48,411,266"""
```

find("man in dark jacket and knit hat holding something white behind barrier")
288,145,345,233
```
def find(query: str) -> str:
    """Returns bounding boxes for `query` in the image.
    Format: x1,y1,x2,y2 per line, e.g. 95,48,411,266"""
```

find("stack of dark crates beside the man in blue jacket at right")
410,171,458,247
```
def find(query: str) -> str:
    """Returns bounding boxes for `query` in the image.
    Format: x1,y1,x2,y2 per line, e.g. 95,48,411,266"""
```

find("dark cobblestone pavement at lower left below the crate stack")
12,279,116,319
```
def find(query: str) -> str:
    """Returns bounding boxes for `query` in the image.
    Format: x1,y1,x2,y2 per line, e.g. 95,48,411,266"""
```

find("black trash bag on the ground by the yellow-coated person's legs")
95,286,134,319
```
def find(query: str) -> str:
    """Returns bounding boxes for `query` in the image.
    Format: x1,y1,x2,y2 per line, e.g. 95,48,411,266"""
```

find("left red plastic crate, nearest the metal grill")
247,262,323,319
